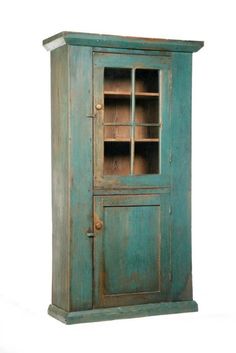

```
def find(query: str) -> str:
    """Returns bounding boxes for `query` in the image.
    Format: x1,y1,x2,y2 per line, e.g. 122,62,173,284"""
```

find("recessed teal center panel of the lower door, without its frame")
103,204,161,294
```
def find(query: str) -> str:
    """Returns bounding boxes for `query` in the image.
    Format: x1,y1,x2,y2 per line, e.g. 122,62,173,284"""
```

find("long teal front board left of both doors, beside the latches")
69,46,93,311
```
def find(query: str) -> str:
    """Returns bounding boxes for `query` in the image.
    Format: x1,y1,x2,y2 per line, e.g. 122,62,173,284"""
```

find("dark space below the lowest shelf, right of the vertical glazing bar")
134,142,159,175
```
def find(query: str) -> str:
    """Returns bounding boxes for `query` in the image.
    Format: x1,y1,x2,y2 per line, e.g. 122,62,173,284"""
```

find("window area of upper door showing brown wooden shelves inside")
103,68,160,175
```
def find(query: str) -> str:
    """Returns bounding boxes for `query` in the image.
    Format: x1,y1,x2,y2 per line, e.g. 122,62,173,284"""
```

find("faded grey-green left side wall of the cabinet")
51,46,69,311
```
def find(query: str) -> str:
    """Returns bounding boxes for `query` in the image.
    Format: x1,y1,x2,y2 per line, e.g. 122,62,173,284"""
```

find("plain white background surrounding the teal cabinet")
0,0,236,353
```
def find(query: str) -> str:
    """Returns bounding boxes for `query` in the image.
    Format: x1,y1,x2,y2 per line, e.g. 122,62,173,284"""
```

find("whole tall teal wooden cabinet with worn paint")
43,32,203,324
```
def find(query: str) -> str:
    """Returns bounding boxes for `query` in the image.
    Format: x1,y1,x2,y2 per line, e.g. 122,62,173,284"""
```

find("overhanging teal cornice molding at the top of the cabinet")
43,32,204,53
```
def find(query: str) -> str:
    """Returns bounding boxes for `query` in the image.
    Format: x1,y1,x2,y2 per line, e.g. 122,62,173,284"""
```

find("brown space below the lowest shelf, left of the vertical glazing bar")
103,142,130,175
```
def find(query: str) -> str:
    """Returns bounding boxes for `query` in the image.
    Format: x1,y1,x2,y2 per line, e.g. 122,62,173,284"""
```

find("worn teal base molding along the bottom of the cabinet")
48,300,198,325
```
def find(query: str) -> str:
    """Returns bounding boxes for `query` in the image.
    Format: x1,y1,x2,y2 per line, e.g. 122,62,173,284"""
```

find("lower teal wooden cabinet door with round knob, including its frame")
93,194,170,308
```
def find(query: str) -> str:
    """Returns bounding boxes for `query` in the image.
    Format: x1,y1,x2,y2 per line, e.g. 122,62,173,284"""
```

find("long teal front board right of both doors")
170,53,192,300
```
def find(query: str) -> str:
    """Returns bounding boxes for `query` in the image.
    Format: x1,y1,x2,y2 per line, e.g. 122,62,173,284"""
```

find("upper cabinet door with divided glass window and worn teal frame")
94,54,169,186
